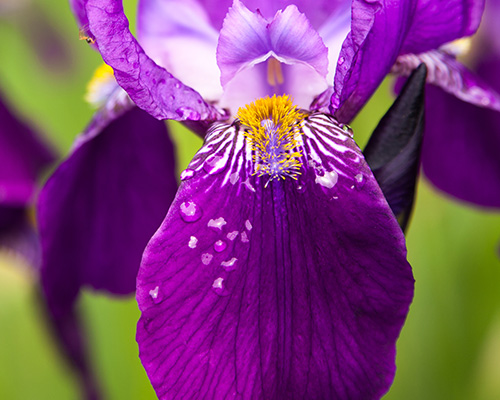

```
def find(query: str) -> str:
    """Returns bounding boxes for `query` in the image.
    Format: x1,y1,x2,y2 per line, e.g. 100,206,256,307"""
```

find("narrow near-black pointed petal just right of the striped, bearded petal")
363,64,427,231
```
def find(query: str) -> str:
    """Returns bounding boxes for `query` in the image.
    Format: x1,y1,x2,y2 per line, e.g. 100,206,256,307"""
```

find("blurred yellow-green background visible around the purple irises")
0,0,500,400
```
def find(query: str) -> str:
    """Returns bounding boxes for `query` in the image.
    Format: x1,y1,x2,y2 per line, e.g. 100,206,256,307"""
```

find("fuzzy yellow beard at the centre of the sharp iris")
238,95,306,180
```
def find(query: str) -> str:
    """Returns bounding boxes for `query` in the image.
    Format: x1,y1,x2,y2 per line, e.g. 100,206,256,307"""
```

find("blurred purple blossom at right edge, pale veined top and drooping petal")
397,0,500,208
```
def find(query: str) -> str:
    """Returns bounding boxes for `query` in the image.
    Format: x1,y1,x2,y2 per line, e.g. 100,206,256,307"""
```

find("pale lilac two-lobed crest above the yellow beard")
217,0,328,86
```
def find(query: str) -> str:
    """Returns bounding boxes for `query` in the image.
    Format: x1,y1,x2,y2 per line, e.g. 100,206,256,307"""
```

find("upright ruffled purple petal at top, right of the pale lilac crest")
331,0,484,122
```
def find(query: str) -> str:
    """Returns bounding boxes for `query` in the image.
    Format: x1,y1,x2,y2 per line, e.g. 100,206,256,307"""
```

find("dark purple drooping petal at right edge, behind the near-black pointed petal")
422,57,500,208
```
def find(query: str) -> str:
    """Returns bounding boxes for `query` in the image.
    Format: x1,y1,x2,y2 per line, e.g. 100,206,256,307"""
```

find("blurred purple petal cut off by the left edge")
0,93,54,207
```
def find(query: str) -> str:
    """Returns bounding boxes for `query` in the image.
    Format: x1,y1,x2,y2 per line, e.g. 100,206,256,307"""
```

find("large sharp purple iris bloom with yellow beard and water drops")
39,0,494,399
